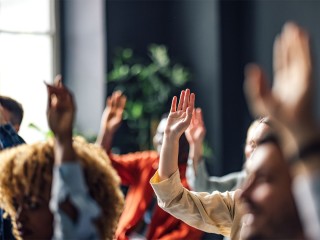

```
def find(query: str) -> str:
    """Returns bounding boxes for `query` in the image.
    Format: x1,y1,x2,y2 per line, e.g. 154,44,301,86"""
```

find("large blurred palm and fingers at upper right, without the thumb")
272,26,311,123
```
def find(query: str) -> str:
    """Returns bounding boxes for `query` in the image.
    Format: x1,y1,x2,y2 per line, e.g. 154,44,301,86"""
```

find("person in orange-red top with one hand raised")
97,92,203,240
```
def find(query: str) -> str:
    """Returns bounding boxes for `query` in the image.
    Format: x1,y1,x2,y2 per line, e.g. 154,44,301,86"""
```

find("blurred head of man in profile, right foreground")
240,142,302,239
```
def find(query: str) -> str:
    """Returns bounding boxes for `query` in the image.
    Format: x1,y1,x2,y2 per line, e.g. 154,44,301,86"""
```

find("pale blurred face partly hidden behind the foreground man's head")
244,121,270,159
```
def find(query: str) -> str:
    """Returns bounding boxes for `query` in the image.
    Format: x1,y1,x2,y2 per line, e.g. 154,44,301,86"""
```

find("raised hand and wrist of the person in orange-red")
96,91,127,152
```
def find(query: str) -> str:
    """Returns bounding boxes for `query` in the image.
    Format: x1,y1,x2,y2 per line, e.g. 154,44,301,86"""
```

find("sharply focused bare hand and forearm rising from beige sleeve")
159,89,195,180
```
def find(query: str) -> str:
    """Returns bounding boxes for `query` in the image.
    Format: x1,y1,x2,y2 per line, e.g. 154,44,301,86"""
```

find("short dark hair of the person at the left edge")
0,96,23,125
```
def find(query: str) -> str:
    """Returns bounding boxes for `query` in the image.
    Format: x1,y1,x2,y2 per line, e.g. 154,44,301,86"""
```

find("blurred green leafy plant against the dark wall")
107,44,191,150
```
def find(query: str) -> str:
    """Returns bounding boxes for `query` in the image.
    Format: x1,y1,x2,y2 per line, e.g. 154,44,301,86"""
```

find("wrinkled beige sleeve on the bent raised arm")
150,170,239,236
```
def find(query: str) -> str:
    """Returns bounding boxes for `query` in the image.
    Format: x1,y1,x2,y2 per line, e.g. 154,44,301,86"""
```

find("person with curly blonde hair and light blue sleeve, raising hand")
0,79,123,239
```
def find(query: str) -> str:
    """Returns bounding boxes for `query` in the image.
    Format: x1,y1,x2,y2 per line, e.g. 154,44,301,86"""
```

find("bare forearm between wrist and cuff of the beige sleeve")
159,134,179,180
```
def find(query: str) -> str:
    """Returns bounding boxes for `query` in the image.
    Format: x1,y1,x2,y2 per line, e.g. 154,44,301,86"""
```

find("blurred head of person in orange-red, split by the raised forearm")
153,118,189,163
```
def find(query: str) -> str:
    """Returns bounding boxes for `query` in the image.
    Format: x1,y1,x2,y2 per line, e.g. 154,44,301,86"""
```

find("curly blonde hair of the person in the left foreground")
0,138,124,239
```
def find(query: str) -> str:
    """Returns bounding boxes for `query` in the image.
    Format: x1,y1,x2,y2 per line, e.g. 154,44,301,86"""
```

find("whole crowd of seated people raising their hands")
0,22,320,240
